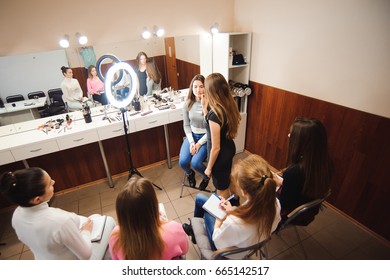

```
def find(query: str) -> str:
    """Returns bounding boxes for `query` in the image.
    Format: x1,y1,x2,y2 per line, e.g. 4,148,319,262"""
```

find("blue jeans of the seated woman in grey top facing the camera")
179,133,208,179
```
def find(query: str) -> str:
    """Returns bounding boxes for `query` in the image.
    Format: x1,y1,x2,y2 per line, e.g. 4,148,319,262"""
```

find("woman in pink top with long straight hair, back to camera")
109,177,188,260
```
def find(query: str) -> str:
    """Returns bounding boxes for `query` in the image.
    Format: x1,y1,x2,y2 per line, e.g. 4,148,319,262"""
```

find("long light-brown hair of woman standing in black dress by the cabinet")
205,73,241,139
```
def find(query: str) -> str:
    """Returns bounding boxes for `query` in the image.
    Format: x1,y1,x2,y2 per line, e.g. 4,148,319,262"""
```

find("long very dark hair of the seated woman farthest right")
287,118,333,199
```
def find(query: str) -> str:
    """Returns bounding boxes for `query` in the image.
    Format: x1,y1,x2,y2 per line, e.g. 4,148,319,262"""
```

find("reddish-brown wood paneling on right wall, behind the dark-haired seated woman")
246,82,390,239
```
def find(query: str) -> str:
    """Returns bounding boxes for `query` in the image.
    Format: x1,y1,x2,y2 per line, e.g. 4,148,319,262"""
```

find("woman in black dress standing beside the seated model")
201,73,241,198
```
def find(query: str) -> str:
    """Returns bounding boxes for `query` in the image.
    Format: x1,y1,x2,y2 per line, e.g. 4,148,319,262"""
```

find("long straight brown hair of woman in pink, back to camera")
114,177,164,260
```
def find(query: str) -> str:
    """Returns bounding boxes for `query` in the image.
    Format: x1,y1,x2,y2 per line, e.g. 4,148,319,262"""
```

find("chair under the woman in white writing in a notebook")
191,217,270,260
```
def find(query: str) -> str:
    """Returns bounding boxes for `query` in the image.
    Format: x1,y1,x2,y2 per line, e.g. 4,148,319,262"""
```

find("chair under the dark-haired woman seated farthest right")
275,189,331,260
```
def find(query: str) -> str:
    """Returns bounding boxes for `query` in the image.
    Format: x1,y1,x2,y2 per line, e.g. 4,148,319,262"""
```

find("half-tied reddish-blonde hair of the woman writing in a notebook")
228,154,277,238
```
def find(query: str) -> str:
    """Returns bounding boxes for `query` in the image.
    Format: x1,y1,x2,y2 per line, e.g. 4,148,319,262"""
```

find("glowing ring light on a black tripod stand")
102,59,162,190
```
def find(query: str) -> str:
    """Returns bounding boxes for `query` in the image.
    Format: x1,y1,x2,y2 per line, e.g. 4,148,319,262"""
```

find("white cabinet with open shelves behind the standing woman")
213,33,252,153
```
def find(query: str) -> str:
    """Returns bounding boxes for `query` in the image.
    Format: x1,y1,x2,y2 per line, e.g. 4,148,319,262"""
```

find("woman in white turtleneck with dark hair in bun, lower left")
0,167,115,260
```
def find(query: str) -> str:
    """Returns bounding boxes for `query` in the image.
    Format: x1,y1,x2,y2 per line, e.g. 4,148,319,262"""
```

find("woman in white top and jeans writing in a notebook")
183,154,280,250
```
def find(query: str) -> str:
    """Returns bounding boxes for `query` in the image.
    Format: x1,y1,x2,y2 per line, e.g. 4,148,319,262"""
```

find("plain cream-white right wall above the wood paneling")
234,0,390,117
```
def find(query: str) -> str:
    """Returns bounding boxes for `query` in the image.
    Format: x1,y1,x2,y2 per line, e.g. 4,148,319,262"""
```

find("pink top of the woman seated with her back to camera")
109,221,188,260
